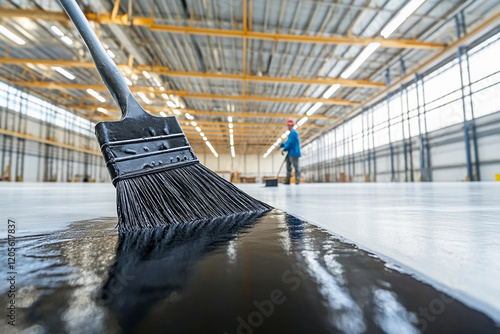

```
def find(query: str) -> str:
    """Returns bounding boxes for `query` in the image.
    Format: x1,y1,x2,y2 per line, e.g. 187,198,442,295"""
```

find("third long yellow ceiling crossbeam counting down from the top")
11,80,361,105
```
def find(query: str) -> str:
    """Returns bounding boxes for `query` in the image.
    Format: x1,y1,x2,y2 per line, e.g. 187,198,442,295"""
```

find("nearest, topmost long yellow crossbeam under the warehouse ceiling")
0,8,445,49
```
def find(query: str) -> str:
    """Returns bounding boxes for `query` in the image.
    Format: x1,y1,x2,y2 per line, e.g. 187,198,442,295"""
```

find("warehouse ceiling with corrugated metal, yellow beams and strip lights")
0,0,500,154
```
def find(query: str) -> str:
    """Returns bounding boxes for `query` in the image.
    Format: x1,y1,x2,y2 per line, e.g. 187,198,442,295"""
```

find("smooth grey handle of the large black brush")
59,0,144,118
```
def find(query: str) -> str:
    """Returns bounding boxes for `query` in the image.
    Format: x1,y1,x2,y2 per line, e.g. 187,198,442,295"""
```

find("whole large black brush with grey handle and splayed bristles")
59,0,272,231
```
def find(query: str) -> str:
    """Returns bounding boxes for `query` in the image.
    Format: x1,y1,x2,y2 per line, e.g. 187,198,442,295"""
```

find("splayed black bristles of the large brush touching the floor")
116,163,273,232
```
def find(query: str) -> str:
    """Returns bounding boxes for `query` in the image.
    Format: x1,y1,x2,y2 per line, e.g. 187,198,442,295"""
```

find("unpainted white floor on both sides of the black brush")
0,182,500,323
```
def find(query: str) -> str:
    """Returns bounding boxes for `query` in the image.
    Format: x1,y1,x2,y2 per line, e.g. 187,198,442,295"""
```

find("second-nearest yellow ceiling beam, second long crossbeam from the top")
0,57,386,88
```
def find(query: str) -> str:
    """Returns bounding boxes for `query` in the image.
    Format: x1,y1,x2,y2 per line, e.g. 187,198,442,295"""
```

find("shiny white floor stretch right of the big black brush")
240,182,500,322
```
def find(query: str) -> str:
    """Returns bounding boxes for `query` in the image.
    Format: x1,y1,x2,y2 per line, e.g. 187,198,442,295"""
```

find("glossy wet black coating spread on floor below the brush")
0,210,499,333
